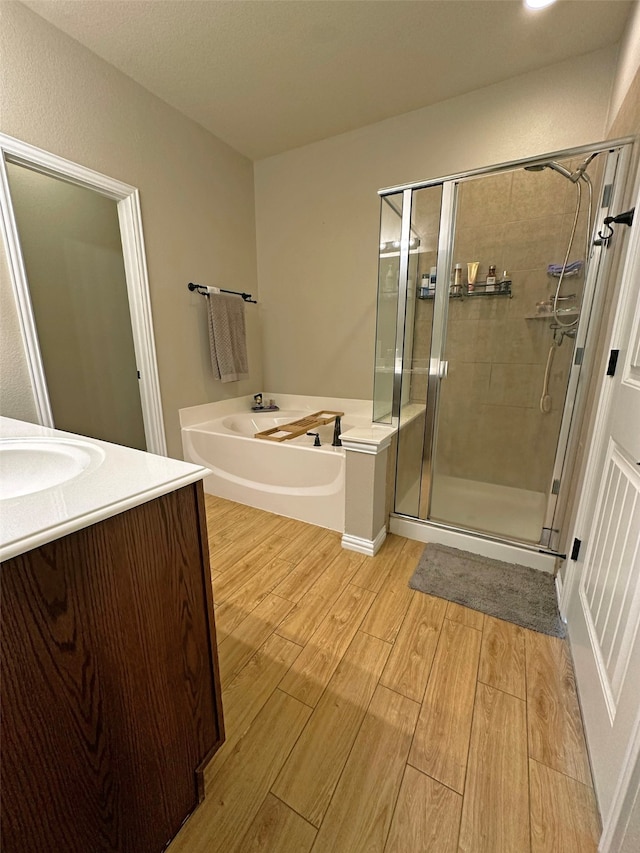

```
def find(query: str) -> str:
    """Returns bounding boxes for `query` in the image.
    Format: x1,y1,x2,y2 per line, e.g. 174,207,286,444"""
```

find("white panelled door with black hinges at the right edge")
564,178,640,850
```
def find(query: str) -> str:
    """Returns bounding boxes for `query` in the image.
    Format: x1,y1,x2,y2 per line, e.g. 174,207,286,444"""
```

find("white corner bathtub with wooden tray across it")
180,394,371,532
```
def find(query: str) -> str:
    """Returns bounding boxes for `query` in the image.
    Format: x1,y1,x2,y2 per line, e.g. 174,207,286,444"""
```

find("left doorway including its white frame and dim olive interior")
0,135,166,455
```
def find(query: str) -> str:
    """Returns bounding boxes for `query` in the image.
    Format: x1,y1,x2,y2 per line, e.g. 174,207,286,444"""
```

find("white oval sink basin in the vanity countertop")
0,438,104,500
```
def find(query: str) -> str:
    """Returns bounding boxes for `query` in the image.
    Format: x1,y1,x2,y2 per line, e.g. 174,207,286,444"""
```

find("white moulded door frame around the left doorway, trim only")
0,133,167,456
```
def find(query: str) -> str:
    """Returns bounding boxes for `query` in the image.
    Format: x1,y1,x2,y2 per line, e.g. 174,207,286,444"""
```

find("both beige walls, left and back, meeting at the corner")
0,3,632,455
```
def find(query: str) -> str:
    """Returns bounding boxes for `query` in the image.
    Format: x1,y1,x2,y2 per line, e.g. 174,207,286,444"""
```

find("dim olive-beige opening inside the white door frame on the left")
7,163,147,450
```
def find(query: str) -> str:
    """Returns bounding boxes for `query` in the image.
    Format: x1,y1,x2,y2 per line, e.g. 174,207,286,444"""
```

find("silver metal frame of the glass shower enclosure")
378,137,635,557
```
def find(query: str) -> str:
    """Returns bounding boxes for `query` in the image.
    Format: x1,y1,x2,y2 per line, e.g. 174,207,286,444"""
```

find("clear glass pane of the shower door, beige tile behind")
430,161,597,543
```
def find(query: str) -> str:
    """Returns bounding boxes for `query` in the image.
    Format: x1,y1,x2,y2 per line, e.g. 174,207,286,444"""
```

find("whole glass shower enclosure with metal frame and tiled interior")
374,143,628,552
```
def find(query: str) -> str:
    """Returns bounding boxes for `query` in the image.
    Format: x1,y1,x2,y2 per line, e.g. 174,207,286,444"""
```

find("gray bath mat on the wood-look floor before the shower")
409,544,565,637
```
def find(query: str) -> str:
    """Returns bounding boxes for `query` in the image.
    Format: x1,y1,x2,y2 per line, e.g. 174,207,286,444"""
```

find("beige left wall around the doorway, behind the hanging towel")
0,2,262,456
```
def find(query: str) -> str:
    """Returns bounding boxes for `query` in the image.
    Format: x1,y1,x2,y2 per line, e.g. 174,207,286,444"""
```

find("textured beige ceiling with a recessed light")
24,0,633,159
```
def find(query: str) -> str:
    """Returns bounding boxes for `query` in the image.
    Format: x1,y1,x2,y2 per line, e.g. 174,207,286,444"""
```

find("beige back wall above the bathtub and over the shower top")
255,49,616,398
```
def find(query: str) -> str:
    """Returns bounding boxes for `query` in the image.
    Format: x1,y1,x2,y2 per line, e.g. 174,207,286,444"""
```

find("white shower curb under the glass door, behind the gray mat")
389,515,556,574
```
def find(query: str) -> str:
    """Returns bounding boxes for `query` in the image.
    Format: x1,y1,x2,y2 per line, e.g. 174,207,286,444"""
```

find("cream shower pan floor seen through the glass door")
431,474,547,545
